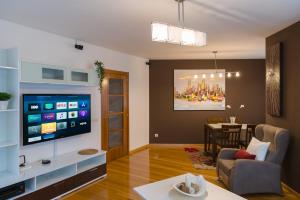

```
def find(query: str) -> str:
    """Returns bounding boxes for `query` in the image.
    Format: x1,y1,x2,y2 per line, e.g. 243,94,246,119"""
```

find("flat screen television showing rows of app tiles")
23,94,91,145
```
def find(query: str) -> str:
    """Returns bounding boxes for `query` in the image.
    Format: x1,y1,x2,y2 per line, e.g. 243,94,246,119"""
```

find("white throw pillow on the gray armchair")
247,137,271,161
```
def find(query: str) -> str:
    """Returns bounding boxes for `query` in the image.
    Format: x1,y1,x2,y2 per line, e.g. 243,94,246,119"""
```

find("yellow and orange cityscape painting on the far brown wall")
174,69,225,110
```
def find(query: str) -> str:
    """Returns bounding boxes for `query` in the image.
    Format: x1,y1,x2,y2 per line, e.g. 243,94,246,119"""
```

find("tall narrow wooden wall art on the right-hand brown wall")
266,43,281,117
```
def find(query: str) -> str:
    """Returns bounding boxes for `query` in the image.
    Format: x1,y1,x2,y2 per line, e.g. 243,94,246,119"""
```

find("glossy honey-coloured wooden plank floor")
64,145,299,200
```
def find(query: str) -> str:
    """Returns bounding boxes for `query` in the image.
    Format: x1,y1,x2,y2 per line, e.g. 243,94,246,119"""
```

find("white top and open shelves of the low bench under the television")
0,150,106,198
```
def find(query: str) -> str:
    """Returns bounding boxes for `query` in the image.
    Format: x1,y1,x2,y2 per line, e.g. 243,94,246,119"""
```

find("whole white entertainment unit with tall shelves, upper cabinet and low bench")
0,48,106,200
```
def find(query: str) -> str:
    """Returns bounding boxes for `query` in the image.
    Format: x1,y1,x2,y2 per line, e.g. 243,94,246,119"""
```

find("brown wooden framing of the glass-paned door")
101,69,129,161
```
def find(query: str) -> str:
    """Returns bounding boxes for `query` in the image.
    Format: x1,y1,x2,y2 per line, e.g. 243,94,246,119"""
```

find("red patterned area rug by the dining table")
184,147,216,169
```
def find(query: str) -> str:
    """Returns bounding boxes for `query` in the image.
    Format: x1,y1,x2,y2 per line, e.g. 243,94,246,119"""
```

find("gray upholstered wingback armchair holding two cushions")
217,124,289,195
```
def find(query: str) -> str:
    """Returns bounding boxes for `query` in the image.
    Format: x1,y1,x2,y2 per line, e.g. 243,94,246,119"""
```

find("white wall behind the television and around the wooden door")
0,20,149,161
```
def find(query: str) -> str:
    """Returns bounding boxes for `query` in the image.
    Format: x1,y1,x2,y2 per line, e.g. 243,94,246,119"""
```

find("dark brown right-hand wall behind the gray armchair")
266,21,300,192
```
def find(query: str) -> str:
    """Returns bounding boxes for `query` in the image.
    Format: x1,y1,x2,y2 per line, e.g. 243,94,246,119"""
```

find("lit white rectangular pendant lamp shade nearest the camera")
151,22,206,46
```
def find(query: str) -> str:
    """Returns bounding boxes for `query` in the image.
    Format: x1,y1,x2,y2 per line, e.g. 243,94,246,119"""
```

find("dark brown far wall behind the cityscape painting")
149,59,265,144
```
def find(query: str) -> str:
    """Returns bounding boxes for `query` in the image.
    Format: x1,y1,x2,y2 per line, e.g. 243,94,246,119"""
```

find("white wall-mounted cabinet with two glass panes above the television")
21,62,97,86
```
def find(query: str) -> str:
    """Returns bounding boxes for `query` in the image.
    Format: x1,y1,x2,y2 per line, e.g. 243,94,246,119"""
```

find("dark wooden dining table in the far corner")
204,123,247,162
